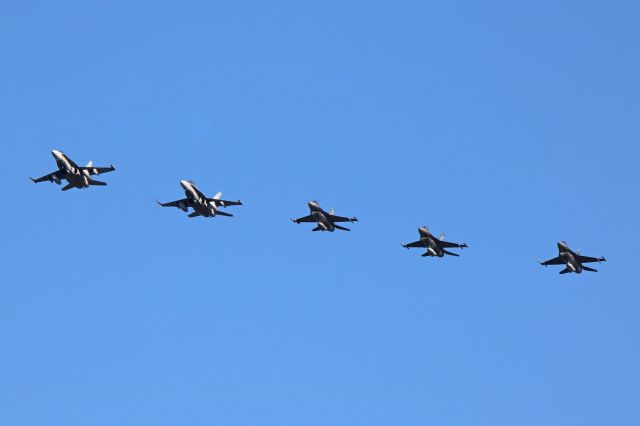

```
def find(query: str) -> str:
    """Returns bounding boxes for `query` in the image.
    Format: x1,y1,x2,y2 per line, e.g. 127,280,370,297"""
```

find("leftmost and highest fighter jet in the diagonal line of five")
30,149,116,191
